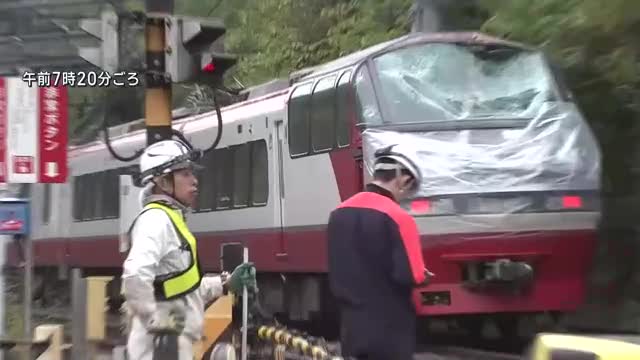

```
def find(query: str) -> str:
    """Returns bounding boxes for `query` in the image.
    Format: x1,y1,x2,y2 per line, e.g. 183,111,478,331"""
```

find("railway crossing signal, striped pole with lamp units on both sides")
78,7,237,146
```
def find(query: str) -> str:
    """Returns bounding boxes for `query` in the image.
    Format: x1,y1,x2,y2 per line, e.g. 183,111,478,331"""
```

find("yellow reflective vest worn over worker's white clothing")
138,202,202,301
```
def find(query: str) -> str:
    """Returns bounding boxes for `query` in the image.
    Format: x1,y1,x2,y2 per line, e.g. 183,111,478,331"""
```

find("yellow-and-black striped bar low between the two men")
258,326,344,360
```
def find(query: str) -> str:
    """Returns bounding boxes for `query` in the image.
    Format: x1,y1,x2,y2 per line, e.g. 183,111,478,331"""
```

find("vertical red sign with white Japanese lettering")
38,86,68,183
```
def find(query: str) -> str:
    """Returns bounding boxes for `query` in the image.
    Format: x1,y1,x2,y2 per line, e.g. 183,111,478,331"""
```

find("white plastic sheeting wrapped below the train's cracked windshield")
363,102,600,196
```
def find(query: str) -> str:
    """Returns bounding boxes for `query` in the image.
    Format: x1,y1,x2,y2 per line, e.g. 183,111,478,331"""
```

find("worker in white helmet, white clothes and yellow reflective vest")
122,140,256,360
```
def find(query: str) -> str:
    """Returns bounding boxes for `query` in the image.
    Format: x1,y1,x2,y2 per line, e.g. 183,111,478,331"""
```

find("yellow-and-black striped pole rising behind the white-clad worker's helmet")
144,0,174,145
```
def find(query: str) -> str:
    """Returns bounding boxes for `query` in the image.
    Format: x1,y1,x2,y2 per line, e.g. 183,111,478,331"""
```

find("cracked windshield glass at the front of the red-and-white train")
373,44,553,122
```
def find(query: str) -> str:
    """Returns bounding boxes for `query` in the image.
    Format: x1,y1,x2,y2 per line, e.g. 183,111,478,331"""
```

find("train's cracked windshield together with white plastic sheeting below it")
356,43,600,200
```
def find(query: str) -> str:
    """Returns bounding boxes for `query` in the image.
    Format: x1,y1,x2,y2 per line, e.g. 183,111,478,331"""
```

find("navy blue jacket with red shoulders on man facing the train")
328,184,425,360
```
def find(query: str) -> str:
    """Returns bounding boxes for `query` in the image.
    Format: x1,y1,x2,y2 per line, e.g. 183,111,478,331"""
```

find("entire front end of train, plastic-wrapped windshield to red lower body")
354,35,600,315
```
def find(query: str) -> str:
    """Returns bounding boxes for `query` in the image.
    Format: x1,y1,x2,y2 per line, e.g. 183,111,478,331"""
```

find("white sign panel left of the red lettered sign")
5,78,39,183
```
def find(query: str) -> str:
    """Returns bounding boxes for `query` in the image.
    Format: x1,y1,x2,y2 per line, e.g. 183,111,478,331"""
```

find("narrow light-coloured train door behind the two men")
272,119,287,259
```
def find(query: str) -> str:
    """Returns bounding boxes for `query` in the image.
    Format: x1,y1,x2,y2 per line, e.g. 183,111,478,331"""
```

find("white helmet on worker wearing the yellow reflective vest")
139,140,202,186
